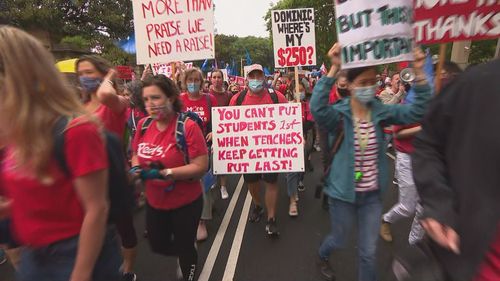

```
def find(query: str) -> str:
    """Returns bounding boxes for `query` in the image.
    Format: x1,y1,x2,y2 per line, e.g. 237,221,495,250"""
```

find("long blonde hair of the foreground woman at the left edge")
0,26,85,179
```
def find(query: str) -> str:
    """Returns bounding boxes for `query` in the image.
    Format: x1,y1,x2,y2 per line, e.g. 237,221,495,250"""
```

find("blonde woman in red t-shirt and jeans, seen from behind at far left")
0,27,121,281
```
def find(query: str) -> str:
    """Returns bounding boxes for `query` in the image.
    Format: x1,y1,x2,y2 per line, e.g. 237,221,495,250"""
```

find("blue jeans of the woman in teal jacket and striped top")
319,191,382,281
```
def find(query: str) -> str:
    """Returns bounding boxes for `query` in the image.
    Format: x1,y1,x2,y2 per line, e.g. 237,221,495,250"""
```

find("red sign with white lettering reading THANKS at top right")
414,0,500,44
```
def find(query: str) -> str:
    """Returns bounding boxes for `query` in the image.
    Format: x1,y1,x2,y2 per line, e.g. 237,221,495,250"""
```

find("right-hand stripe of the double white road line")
222,188,252,281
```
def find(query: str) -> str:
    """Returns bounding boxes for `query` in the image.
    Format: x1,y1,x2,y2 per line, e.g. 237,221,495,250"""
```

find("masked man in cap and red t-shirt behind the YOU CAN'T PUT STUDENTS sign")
229,64,288,235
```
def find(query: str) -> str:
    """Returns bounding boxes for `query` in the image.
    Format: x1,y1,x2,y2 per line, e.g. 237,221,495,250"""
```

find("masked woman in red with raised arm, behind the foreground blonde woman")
76,55,138,280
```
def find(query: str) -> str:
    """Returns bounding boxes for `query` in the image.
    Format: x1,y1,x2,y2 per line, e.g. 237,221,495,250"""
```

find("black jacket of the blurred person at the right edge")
413,59,500,281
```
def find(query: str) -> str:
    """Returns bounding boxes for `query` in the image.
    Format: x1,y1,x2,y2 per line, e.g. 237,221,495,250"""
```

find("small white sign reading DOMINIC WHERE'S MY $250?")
271,8,316,67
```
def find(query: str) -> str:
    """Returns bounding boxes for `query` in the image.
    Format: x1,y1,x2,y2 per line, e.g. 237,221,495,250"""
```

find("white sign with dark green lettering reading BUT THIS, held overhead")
335,0,414,68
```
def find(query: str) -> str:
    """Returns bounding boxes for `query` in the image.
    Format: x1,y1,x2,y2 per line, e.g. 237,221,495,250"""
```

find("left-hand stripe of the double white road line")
198,176,244,281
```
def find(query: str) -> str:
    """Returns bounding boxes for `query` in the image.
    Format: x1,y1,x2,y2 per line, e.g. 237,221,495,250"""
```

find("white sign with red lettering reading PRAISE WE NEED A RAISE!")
132,0,215,64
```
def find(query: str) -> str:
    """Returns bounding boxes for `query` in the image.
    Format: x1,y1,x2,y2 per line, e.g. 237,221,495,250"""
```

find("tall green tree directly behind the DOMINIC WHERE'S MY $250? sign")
264,0,337,68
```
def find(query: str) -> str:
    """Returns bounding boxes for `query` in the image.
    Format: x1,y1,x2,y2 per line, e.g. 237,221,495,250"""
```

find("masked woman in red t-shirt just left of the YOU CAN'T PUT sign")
180,68,217,241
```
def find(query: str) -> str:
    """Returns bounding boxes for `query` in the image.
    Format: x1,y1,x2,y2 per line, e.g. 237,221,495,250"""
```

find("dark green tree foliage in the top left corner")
0,0,133,63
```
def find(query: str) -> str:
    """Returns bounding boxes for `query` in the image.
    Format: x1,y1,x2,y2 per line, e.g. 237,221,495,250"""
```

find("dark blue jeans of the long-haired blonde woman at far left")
17,227,122,281
